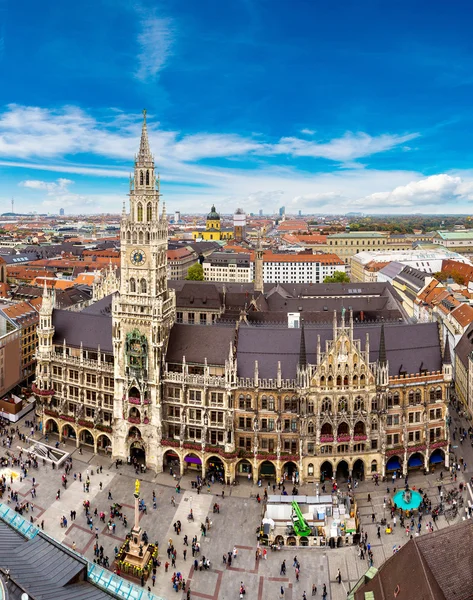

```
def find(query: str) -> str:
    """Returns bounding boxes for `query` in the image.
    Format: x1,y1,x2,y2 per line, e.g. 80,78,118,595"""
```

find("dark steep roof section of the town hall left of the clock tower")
53,310,113,352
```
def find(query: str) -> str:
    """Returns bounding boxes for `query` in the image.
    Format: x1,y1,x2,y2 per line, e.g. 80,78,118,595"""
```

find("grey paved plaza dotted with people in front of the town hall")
0,418,473,600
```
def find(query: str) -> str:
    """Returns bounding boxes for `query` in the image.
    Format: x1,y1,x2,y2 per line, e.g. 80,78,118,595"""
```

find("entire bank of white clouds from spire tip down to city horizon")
0,105,473,213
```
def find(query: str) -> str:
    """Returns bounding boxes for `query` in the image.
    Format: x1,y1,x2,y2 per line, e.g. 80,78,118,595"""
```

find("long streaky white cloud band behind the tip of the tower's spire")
0,105,419,169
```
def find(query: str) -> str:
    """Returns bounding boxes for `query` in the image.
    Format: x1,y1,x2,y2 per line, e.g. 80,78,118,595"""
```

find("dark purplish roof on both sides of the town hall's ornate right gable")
237,322,442,379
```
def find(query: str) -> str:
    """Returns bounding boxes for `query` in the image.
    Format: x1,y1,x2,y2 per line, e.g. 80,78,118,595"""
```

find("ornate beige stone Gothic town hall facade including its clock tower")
34,119,452,482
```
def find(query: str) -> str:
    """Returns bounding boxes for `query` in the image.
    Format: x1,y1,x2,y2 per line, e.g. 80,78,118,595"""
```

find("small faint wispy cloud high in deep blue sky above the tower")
136,16,173,81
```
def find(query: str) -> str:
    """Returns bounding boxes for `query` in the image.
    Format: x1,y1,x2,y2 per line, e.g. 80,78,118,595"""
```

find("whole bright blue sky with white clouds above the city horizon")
0,0,473,214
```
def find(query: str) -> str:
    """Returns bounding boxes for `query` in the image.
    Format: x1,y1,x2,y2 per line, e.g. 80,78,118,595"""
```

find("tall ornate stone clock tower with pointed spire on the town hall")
112,111,176,471
